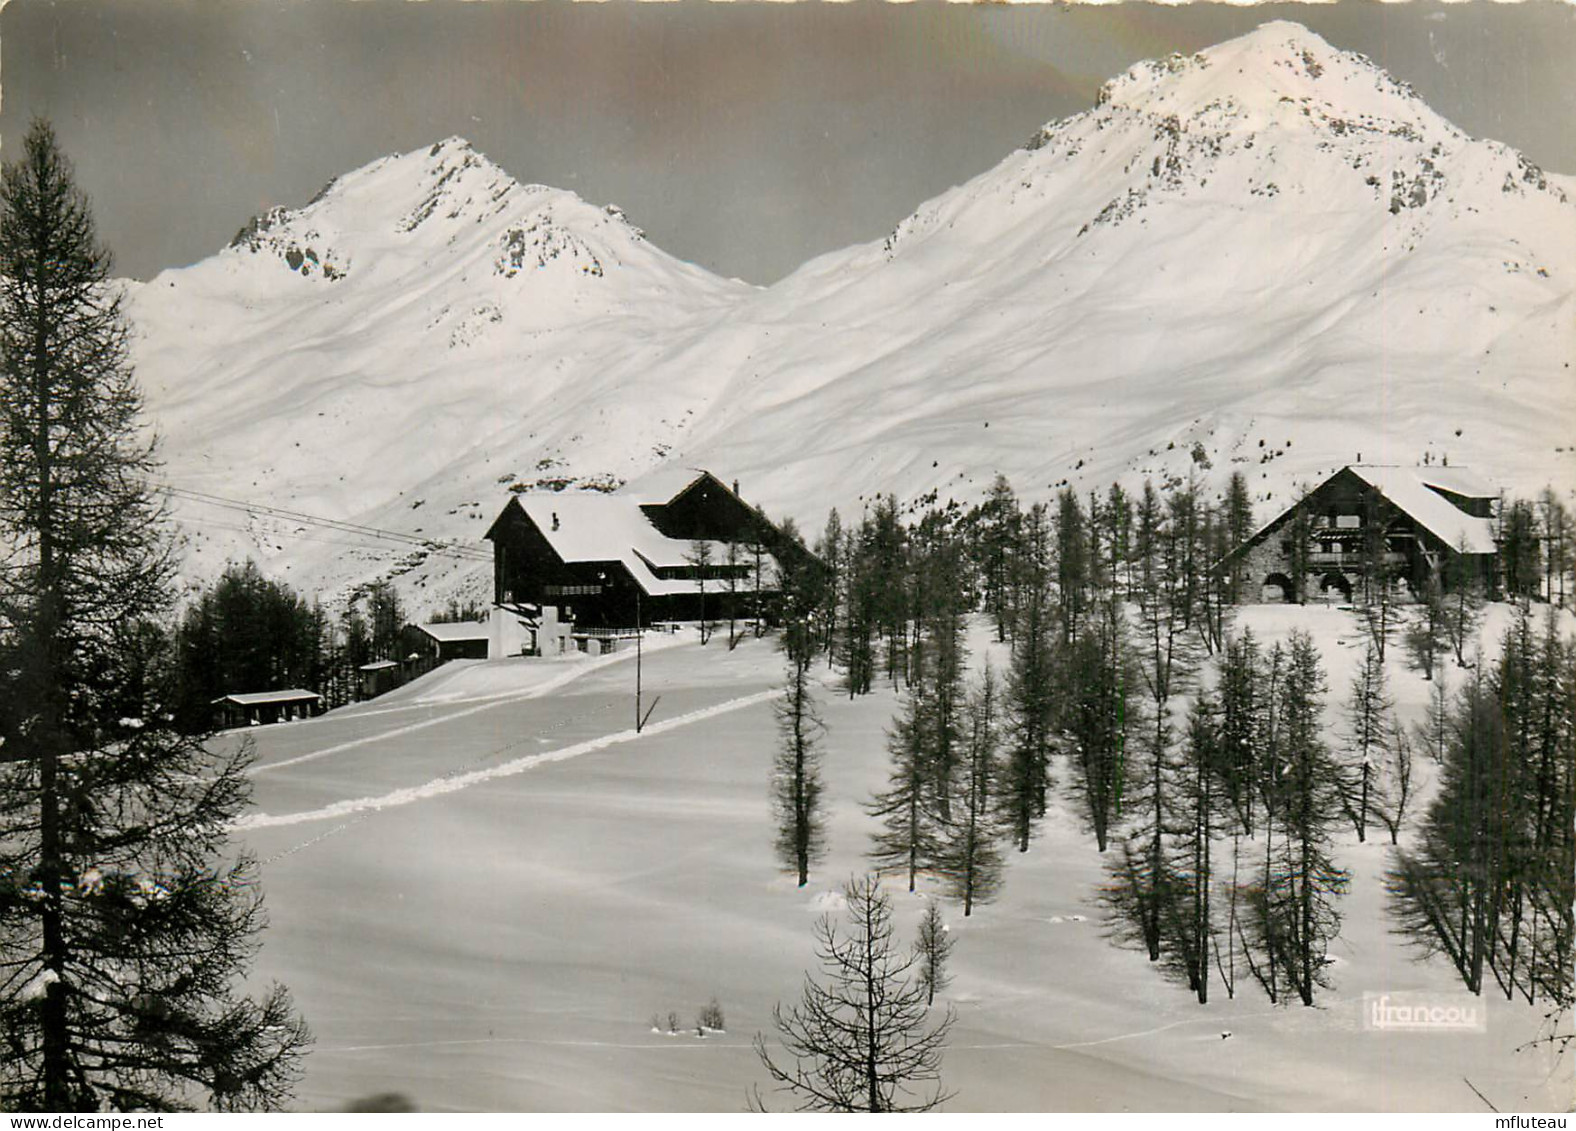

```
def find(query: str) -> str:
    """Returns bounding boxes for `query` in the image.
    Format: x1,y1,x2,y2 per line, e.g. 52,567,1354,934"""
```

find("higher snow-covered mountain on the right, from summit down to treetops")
680,24,1576,522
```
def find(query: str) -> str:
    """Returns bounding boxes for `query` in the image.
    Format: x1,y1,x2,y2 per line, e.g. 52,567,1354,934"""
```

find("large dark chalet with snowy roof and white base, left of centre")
484,471,810,657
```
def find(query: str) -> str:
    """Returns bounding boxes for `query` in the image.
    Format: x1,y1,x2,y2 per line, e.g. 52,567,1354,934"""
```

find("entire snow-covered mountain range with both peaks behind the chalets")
132,22,1576,611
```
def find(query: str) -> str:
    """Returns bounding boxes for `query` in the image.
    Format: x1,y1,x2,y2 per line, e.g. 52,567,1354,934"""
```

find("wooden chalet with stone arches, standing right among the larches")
1221,463,1499,600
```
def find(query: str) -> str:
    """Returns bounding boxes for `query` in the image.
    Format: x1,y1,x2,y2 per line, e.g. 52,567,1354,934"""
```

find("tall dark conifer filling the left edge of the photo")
0,121,307,1111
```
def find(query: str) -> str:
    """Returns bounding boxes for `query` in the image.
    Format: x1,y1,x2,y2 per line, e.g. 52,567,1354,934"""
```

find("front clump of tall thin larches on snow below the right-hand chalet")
1105,632,1346,1005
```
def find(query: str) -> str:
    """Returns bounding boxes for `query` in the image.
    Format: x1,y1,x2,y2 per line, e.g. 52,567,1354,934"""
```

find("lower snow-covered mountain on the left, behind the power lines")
129,137,750,601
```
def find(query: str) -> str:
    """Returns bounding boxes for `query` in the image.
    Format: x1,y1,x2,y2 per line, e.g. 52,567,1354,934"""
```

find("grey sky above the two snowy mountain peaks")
0,0,1576,282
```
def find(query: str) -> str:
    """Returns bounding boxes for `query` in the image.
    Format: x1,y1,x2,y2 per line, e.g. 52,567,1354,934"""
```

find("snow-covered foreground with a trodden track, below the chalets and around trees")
241,606,1573,1111
